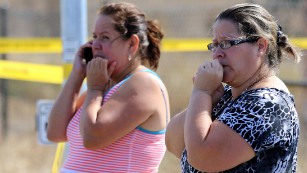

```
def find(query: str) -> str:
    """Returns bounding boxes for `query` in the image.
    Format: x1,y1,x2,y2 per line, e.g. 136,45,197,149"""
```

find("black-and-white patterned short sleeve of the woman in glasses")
216,90,293,153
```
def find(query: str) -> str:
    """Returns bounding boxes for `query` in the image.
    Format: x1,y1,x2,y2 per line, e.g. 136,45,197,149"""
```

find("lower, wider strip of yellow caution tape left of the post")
0,60,63,84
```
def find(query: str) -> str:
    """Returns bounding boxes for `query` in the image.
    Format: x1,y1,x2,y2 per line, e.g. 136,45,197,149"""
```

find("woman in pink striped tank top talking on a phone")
48,3,169,173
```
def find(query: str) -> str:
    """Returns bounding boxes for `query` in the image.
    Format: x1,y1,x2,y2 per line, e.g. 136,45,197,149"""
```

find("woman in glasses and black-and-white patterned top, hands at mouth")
166,3,300,173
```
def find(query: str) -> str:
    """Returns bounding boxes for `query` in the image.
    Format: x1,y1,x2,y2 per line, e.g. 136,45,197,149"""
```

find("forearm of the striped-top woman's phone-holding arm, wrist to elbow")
47,73,84,142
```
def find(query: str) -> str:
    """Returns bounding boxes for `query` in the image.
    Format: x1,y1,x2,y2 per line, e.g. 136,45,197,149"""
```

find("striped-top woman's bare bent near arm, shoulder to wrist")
80,65,165,149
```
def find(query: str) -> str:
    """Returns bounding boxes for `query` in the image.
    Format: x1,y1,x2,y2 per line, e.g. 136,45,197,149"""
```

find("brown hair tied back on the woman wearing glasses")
215,3,300,68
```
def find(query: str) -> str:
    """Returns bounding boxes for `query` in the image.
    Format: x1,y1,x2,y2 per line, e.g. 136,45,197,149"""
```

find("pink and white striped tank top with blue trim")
61,69,167,173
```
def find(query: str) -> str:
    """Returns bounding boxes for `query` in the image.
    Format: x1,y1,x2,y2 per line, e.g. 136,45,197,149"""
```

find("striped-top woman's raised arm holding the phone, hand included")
47,43,90,142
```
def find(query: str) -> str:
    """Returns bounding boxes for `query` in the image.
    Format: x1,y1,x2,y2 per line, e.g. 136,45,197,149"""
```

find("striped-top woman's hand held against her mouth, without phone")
86,57,116,91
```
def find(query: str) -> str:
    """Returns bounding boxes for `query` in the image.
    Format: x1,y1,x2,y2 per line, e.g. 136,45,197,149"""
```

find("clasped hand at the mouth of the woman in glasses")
194,60,223,96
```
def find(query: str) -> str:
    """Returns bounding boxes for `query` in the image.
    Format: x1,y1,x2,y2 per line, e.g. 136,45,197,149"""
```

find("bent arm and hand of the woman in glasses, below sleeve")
184,61,255,172
